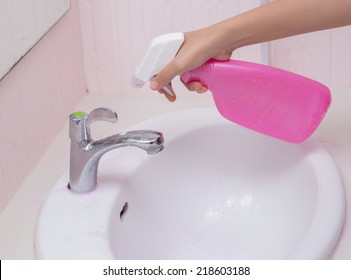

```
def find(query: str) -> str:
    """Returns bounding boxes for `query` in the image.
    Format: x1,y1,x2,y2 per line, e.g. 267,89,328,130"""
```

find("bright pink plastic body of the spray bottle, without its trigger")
181,60,331,143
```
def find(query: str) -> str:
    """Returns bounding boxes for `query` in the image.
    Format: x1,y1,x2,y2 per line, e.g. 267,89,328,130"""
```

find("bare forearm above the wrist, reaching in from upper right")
214,0,351,50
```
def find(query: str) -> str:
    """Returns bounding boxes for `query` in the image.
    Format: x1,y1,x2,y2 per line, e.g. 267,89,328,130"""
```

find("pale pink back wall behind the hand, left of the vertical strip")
79,0,261,94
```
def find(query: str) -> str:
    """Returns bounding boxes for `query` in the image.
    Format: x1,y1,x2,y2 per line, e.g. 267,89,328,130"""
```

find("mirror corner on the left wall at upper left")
0,0,70,79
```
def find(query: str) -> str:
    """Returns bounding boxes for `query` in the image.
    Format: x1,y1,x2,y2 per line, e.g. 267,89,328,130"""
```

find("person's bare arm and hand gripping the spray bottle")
150,0,351,101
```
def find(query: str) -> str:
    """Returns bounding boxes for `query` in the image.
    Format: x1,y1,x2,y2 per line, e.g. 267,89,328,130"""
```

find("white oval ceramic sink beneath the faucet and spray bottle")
35,109,345,259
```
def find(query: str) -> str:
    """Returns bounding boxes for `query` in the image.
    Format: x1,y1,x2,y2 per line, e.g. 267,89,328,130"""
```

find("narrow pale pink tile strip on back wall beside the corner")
79,0,119,93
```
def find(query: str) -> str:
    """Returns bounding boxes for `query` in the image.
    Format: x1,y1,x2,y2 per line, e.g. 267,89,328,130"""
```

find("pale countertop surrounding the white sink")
0,89,351,260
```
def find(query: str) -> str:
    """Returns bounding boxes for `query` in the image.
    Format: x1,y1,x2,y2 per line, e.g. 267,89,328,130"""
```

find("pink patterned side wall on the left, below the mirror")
0,1,86,210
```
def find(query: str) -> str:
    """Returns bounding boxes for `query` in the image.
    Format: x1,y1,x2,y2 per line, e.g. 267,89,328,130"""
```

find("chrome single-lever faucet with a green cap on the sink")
68,108,164,193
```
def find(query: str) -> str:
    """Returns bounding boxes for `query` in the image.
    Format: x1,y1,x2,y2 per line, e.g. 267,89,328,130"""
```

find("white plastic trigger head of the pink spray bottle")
132,32,184,95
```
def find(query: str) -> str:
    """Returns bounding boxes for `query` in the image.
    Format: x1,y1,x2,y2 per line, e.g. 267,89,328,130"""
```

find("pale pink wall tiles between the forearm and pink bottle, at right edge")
270,21,351,87
